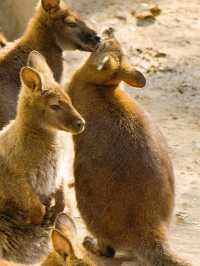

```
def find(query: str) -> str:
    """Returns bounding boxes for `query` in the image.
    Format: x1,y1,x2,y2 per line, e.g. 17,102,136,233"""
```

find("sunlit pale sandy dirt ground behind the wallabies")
0,0,200,266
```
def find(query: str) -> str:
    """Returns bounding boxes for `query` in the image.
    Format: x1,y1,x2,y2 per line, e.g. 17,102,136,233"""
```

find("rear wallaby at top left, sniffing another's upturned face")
0,0,99,127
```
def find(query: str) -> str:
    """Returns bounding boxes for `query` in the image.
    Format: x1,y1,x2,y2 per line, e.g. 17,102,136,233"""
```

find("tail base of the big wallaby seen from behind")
138,242,192,266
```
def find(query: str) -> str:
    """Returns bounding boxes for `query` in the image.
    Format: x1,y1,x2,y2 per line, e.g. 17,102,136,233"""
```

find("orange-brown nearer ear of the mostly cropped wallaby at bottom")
51,229,74,256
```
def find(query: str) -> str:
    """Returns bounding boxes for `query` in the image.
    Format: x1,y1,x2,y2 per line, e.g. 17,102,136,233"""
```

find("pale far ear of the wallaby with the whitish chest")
27,51,53,77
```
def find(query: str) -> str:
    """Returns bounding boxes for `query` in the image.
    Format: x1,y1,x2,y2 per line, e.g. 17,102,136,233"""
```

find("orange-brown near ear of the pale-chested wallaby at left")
20,67,42,91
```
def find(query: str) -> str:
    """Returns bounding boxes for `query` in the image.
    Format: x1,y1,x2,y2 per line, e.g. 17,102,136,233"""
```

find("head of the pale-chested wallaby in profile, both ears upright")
18,51,85,134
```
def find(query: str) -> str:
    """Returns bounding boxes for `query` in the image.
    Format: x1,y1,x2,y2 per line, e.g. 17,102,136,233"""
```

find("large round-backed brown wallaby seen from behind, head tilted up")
68,29,190,266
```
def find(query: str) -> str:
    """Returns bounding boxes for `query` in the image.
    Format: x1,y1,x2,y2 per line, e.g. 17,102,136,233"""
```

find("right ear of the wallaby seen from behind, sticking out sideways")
120,56,146,88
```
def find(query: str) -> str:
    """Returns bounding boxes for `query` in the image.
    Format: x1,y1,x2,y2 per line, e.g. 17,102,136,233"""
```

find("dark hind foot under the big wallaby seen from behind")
83,236,115,258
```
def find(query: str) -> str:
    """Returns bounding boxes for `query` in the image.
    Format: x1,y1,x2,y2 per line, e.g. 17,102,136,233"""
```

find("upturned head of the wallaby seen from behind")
79,28,146,88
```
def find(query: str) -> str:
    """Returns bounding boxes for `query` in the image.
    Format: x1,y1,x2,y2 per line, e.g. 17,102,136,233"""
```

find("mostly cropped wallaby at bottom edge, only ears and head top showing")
41,213,92,266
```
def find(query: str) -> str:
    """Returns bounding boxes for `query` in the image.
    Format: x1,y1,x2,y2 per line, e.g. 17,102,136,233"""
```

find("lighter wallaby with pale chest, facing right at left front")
0,51,84,264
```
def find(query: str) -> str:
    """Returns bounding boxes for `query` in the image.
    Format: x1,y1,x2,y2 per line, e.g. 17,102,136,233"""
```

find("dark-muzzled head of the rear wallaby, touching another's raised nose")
41,0,100,51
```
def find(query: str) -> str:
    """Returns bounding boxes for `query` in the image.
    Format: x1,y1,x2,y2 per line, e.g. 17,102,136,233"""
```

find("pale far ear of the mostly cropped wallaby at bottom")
55,213,77,239
